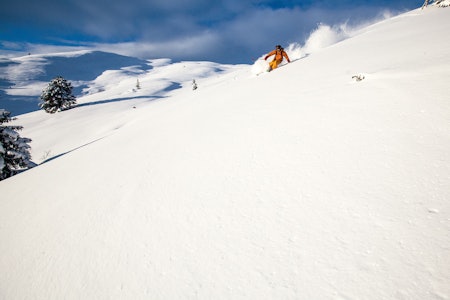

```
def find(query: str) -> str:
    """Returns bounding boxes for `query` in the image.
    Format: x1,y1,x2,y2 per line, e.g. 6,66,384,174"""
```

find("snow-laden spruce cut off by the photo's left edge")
0,109,34,180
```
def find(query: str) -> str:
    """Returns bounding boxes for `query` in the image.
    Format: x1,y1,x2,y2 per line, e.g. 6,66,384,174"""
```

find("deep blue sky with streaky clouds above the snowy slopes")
0,0,423,63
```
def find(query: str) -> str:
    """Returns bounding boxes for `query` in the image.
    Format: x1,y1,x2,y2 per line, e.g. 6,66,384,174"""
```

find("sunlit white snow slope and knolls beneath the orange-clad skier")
0,6,450,300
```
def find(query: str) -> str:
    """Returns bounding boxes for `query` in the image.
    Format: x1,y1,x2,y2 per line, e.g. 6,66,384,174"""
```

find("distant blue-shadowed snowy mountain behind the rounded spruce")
0,51,152,115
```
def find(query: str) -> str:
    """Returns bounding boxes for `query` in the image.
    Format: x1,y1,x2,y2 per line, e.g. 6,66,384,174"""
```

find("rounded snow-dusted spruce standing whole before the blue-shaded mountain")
39,76,76,114
